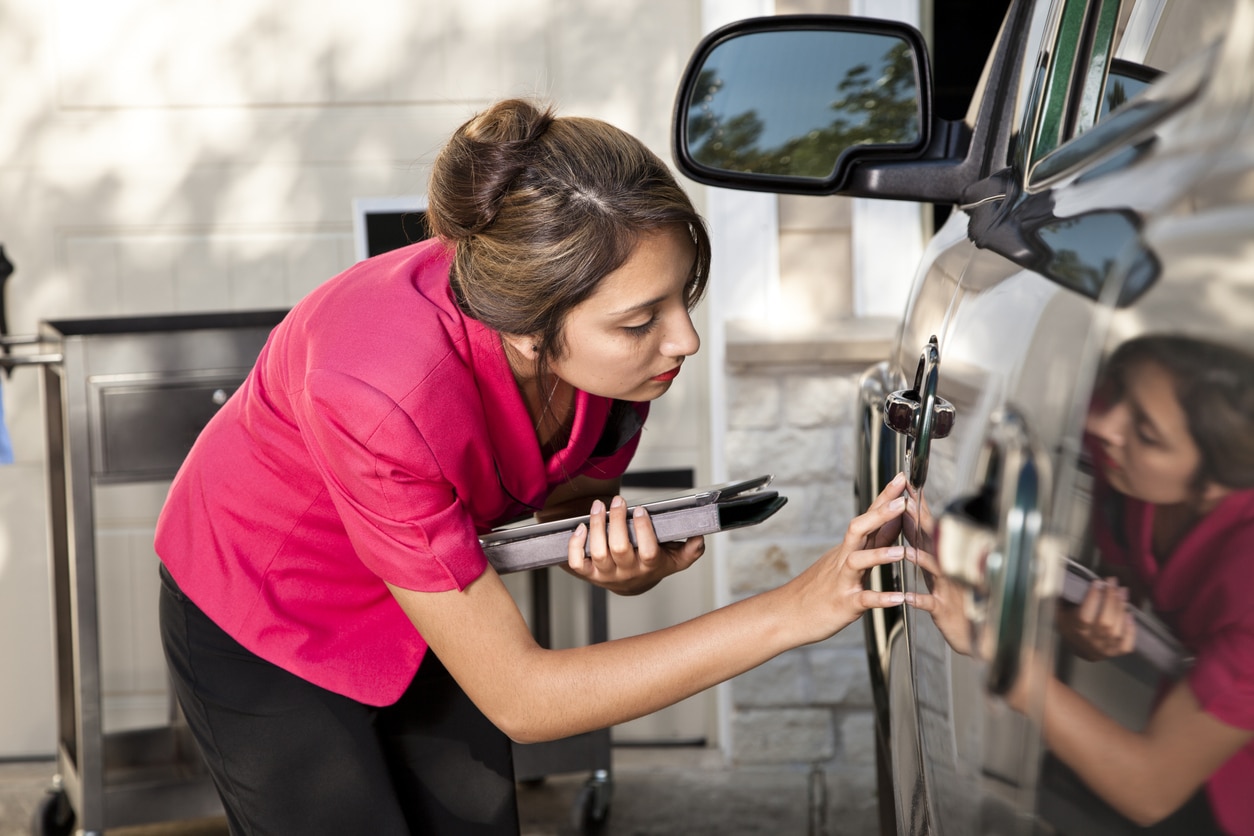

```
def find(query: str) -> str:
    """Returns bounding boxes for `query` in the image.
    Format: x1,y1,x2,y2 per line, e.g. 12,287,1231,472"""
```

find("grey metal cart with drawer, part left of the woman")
0,311,286,836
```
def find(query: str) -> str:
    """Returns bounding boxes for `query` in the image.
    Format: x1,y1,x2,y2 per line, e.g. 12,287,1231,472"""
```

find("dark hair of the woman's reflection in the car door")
1100,335,1254,489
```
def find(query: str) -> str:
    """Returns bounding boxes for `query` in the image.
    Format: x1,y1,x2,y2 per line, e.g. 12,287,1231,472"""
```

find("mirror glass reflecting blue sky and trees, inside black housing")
687,30,922,179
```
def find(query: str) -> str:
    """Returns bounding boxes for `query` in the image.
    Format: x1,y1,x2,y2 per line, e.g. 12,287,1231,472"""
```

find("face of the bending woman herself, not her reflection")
549,227,701,401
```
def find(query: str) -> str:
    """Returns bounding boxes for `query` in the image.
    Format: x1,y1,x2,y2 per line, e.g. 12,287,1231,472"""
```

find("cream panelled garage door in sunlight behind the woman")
0,0,709,757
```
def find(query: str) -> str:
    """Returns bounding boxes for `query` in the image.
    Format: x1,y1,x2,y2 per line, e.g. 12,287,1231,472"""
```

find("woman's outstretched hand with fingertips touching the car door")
780,474,905,644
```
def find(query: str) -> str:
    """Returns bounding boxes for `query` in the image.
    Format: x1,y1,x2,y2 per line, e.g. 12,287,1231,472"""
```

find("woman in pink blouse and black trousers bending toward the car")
157,100,904,835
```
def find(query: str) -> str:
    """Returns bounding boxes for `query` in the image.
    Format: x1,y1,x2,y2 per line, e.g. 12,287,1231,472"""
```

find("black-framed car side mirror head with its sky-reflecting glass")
673,15,930,194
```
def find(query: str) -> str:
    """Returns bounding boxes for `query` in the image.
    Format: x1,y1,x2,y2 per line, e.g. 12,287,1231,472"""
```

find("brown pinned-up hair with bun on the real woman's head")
428,99,710,367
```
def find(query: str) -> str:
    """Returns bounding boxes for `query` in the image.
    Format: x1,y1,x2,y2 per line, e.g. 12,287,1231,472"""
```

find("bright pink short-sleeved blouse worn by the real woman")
155,239,648,706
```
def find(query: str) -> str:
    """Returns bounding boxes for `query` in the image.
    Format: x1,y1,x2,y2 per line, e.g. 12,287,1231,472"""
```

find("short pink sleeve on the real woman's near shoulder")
297,371,487,592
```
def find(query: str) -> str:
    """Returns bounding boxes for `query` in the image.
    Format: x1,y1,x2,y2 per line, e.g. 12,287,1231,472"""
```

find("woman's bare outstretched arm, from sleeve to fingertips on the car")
393,479,904,742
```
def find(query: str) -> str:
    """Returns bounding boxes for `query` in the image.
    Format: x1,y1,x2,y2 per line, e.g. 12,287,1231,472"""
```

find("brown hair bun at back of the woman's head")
428,99,554,241
